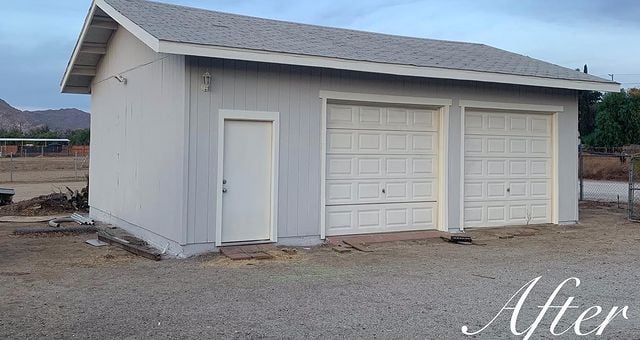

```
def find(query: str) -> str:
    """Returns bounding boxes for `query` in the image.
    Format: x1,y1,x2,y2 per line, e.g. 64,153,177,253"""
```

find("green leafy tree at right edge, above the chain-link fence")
590,90,640,147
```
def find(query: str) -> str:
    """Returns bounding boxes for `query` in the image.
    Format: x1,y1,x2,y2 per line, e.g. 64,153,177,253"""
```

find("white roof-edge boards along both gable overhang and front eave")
61,0,620,93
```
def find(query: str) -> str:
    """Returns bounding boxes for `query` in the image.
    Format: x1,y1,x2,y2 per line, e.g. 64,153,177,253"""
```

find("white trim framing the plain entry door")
215,110,280,247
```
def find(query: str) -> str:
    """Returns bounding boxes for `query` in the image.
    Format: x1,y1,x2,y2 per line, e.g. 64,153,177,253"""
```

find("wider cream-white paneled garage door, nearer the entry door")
325,104,438,236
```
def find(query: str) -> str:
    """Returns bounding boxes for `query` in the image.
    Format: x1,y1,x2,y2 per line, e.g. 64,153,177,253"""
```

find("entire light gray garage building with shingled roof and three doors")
62,0,619,255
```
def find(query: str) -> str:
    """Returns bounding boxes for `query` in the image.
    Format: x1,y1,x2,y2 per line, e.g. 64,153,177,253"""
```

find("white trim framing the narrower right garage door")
458,100,564,230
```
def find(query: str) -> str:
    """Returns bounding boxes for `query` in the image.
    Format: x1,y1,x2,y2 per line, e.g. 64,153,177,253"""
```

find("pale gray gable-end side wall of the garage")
89,28,186,244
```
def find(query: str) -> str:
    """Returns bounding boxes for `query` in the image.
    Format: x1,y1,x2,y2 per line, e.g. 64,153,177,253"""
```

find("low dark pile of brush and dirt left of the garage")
0,193,77,216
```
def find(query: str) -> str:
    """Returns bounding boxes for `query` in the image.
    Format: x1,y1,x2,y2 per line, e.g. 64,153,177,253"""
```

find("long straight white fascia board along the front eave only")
156,40,620,92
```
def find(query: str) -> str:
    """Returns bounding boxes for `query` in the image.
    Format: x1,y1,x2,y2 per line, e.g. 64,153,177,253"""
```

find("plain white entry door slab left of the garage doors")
221,119,274,242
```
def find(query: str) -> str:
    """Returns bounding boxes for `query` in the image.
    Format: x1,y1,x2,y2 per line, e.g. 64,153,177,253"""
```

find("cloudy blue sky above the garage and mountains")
0,0,640,110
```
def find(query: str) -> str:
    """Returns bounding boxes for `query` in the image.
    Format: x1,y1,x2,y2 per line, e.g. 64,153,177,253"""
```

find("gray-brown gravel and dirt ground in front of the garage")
0,205,640,339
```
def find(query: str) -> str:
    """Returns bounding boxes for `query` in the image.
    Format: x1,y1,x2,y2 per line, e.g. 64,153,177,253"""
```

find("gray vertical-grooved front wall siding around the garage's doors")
187,58,578,243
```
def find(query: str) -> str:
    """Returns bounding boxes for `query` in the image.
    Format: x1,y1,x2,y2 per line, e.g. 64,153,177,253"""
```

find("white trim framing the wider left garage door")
319,90,452,240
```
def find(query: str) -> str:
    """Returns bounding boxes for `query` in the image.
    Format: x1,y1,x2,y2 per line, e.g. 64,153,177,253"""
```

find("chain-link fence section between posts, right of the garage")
578,147,632,206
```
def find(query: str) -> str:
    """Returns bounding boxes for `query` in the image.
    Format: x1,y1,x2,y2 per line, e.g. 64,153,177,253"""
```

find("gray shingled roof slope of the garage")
105,0,613,83
